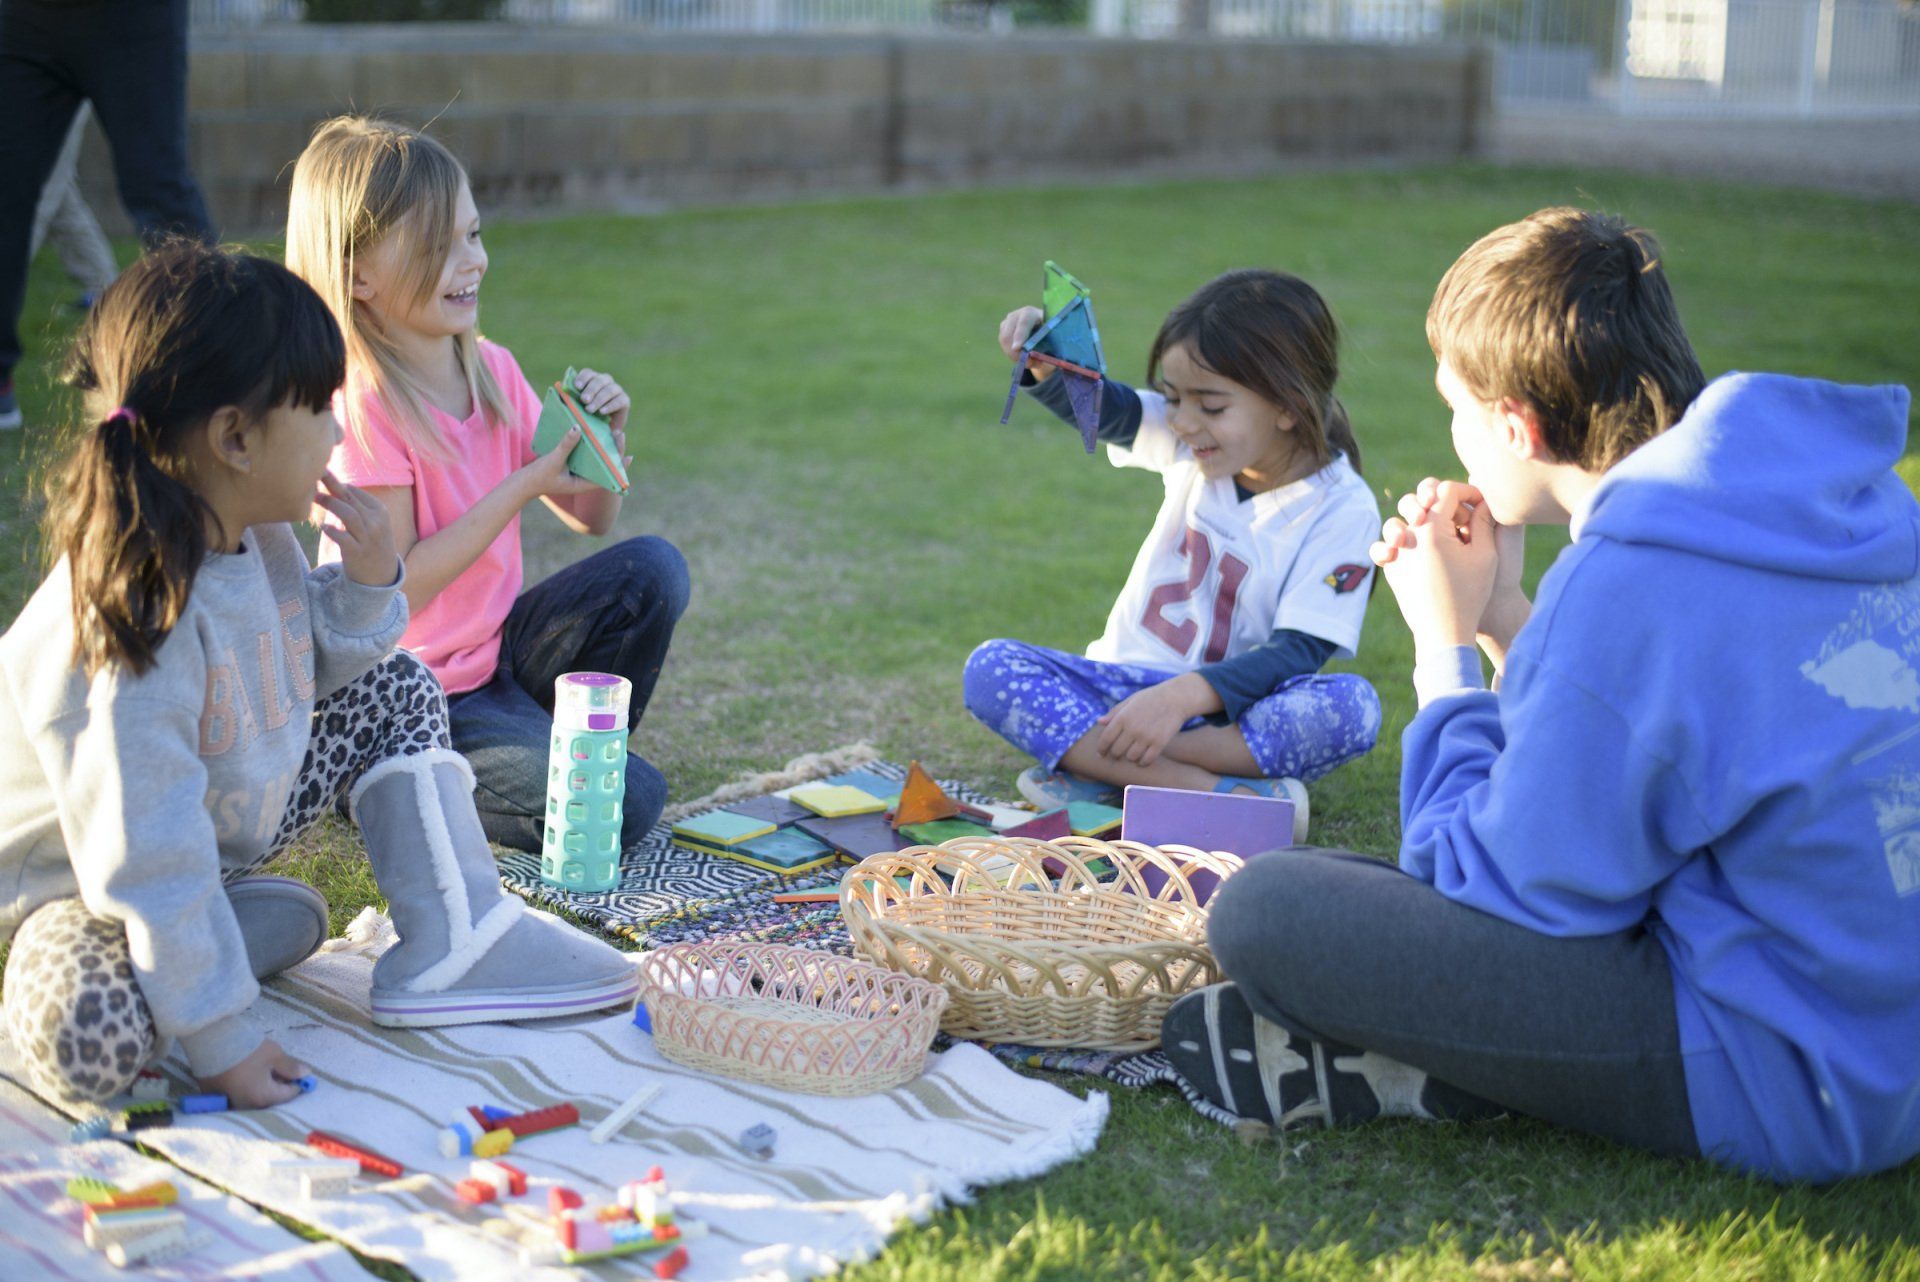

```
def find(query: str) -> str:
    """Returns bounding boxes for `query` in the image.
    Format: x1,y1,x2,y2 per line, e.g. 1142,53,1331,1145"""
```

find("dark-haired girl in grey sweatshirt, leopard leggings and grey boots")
0,244,634,1107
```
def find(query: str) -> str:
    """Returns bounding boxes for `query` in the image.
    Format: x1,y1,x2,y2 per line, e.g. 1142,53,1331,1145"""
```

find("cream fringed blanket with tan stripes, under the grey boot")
0,912,1106,1282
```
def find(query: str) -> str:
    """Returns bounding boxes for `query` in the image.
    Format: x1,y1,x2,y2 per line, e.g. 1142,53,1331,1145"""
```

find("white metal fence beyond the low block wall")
192,0,1920,113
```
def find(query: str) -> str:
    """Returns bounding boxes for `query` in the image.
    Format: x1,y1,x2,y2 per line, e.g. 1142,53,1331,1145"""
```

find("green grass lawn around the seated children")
0,167,1920,1282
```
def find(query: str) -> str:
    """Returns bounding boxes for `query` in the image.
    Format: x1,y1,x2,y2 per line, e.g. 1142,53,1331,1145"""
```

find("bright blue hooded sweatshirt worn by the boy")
1400,374,1920,1180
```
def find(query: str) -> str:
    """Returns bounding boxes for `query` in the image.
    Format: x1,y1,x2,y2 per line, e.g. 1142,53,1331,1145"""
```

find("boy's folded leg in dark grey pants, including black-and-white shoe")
1165,848,1699,1155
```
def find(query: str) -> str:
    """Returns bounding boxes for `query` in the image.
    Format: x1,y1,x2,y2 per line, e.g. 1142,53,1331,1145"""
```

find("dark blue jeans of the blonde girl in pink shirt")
447,537,691,850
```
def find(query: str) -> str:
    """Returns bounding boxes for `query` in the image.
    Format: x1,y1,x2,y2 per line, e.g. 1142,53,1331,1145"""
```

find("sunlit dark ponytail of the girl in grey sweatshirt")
52,407,219,677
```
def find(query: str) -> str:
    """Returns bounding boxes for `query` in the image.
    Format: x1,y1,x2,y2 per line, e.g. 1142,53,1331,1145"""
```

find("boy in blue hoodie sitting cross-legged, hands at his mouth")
1164,209,1920,1180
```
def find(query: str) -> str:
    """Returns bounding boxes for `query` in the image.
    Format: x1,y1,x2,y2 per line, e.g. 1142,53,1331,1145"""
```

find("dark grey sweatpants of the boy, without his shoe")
1208,848,1699,1155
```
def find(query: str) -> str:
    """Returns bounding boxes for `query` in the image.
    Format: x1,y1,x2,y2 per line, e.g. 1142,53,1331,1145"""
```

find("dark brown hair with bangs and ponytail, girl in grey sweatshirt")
46,240,346,676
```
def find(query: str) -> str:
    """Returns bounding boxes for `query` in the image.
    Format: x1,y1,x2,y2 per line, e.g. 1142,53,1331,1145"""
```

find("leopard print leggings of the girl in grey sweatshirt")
4,651,451,1100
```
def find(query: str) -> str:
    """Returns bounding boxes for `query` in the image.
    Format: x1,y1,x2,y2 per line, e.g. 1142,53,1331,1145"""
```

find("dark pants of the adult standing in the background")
0,0,213,391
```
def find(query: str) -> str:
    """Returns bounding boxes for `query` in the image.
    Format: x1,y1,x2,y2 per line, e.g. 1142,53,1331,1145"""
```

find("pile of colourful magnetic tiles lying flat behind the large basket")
672,762,1121,873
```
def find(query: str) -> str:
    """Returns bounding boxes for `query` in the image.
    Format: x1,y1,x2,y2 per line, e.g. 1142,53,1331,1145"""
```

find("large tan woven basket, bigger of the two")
841,837,1240,1052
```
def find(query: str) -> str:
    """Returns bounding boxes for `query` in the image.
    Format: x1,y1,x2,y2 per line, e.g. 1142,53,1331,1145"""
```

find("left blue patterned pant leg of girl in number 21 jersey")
960,639,1204,770
